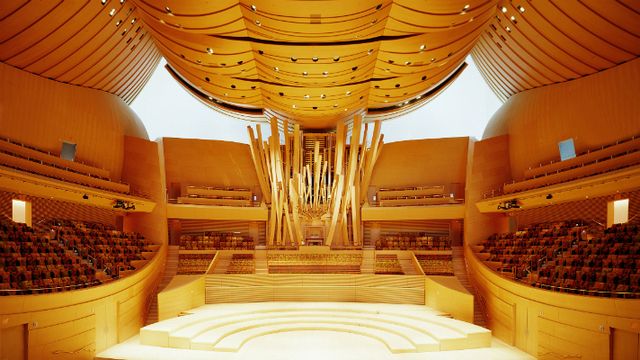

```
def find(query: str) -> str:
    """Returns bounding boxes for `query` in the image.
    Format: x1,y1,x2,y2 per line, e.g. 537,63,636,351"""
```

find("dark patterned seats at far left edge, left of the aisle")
0,222,101,295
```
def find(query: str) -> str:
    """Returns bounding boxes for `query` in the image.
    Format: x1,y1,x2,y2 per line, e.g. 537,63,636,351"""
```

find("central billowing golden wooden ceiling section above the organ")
132,0,496,128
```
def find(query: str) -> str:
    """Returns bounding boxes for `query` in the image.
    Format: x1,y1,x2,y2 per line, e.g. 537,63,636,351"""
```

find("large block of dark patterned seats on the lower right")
478,222,640,298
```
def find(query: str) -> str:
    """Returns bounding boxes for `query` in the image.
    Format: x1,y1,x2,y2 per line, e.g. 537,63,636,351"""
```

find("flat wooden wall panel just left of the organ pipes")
162,138,260,197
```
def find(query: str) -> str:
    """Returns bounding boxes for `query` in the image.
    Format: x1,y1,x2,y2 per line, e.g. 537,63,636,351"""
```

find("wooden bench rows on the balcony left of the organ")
178,185,253,206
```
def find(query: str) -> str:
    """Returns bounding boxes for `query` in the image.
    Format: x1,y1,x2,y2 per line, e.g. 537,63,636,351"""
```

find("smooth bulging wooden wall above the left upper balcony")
0,64,147,180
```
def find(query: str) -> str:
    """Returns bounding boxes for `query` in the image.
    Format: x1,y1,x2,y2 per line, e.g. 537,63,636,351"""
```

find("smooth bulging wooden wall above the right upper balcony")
483,59,640,179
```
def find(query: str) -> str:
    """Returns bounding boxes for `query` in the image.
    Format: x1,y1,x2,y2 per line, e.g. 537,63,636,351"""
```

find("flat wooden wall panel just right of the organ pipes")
370,137,469,190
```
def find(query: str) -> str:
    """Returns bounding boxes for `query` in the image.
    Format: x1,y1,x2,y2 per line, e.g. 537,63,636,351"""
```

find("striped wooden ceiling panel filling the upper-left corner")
0,0,161,103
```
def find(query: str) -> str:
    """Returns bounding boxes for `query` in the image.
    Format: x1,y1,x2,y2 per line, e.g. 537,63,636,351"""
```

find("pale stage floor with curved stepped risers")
96,302,533,360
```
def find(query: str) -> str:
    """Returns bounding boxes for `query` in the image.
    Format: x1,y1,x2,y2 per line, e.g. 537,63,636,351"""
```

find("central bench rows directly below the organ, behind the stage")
267,253,362,274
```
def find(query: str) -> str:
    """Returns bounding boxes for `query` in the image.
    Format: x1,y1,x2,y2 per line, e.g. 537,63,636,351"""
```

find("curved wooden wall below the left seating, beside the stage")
0,246,166,359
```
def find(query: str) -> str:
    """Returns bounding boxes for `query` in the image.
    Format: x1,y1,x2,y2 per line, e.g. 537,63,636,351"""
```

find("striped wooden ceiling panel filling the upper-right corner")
471,0,640,101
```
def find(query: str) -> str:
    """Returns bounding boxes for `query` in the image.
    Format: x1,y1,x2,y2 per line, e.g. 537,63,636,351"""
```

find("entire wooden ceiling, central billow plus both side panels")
0,0,640,129
